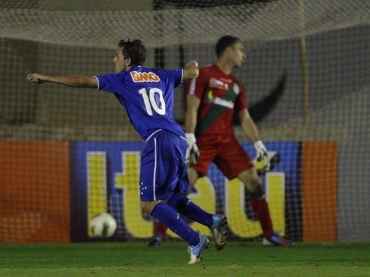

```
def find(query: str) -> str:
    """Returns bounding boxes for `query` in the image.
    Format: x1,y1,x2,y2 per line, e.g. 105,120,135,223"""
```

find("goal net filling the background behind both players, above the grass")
0,0,370,243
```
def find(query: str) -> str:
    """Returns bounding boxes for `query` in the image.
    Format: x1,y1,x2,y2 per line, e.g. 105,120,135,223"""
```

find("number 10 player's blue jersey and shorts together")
96,66,189,202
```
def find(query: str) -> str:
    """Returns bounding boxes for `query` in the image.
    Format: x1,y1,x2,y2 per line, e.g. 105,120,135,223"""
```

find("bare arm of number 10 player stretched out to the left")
27,73,98,88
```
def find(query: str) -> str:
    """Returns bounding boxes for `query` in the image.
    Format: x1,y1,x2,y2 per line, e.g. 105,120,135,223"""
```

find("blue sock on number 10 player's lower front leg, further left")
151,203,199,245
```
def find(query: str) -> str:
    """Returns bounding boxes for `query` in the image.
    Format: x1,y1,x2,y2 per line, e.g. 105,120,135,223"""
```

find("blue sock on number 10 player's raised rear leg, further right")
168,194,213,228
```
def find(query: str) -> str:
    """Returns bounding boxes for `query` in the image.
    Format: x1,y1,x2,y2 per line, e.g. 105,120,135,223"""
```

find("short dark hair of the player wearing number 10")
118,39,146,65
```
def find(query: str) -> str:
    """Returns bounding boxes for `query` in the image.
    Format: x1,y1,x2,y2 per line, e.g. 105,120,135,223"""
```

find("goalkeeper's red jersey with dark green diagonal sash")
187,64,247,141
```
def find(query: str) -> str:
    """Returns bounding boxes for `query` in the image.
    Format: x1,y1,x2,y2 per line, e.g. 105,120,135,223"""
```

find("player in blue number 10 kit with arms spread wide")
27,40,226,264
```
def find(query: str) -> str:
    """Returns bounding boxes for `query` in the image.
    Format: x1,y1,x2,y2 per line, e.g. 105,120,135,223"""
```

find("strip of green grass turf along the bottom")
0,242,370,277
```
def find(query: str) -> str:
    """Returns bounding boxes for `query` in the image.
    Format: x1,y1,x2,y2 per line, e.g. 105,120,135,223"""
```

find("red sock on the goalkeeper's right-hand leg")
249,195,274,238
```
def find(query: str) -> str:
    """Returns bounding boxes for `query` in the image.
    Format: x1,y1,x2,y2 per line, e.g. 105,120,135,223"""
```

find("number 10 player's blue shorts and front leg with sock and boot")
140,131,209,263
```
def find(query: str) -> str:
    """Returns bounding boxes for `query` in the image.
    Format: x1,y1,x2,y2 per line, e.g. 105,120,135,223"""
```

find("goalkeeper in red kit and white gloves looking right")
149,36,294,246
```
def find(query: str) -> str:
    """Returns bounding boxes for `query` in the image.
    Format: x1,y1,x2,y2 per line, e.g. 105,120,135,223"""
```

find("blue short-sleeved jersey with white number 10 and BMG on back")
96,66,185,140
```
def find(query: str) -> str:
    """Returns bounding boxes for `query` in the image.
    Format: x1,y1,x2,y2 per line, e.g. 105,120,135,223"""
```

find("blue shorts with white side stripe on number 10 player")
140,130,190,202
